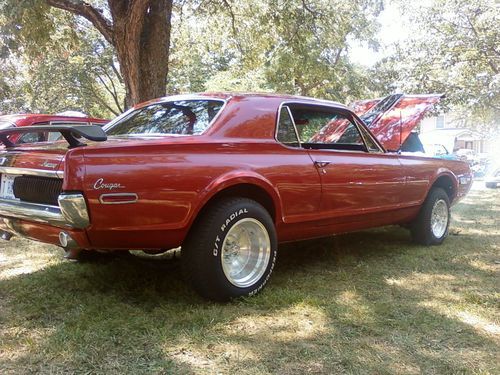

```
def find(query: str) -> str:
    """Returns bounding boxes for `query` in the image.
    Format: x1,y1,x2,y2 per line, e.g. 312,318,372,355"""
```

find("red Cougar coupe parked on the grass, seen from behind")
0,93,471,300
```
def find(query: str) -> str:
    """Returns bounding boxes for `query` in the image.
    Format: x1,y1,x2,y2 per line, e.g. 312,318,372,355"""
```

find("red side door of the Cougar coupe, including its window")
288,103,405,222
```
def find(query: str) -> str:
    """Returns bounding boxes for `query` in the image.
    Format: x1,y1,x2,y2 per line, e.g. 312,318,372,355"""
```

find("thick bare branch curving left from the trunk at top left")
45,0,114,44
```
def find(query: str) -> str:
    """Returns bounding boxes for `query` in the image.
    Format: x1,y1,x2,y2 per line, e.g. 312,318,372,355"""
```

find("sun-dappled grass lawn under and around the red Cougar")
0,185,500,374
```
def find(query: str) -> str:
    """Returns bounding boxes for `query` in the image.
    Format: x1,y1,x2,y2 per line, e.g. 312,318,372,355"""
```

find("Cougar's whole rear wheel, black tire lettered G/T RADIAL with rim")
181,198,277,302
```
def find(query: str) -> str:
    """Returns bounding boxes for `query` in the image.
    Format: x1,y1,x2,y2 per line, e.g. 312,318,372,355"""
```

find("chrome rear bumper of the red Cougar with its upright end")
0,194,90,229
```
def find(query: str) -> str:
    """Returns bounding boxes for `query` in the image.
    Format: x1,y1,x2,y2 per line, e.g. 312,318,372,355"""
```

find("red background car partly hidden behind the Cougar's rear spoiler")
0,112,109,147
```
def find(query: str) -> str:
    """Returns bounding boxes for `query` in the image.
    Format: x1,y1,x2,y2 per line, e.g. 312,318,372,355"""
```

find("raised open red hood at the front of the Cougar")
351,94,444,151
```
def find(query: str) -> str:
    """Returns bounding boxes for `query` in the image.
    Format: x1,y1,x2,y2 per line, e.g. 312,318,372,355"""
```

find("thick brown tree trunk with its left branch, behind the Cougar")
46,0,173,107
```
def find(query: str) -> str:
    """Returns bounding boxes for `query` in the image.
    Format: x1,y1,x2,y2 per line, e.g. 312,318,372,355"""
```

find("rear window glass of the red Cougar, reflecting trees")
104,99,224,135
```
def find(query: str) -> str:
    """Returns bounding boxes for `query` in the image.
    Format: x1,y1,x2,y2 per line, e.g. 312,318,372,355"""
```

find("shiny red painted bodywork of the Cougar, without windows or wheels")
0,93,470,250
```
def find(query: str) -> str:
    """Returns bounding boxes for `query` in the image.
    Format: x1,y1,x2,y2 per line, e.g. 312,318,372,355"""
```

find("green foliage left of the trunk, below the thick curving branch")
0,1,124,117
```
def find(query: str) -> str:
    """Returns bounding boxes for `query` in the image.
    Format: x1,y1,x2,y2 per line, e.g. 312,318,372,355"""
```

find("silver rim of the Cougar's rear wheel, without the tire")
221,218,271,288
